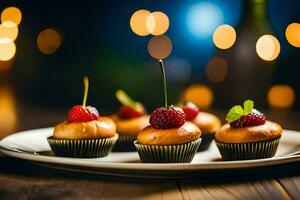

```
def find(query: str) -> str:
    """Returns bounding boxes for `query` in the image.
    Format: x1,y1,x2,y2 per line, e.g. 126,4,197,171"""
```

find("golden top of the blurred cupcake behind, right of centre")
192,112,221,135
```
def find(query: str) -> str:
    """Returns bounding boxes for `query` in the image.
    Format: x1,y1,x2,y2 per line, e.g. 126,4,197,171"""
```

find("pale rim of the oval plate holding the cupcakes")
0,127,300,171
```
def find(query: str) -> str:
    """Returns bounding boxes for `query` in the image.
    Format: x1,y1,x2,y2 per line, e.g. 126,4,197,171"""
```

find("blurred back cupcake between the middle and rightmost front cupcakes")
179,102,221,151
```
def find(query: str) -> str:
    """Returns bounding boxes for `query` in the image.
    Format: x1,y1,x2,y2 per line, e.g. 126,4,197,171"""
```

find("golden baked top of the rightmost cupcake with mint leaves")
215,121,282,143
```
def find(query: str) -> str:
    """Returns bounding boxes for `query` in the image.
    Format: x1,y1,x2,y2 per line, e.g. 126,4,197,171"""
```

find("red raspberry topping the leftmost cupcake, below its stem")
68,105,99,123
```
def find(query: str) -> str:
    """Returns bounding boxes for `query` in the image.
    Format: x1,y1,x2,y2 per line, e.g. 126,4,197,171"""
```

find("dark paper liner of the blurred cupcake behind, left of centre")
112,135,136,152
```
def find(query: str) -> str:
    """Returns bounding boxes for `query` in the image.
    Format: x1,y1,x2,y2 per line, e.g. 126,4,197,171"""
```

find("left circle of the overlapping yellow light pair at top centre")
130,10,151,36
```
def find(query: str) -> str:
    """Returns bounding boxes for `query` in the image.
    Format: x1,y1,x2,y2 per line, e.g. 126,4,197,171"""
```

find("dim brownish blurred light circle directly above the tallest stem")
148,35,172,59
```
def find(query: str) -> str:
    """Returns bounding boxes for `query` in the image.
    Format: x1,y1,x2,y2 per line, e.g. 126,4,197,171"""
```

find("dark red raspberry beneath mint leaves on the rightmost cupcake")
230,109,266,128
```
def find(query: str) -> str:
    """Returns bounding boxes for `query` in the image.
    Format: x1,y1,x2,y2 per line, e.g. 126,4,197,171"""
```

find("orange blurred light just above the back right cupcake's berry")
183,84,214,109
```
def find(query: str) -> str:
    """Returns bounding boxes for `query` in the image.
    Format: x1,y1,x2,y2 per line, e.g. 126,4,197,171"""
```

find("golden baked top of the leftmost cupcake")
53,117,116,140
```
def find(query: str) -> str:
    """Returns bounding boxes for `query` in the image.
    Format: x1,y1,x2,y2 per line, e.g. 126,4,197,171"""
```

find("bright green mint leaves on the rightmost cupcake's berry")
225,100,254,123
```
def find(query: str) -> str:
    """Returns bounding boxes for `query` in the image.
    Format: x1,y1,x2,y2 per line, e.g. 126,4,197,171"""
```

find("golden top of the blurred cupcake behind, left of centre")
111,115,149,136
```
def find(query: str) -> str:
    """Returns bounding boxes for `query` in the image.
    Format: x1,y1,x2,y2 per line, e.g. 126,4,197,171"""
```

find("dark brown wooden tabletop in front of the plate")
0,157,300,200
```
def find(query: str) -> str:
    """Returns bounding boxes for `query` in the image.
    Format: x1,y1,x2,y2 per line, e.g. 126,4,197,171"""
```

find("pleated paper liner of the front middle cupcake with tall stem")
134,138,201,163
